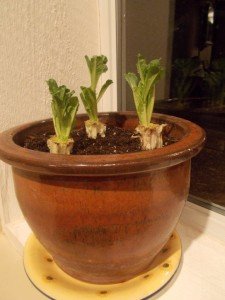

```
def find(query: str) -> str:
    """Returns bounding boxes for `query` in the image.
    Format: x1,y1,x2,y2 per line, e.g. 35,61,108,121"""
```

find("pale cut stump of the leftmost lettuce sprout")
47,136,74,155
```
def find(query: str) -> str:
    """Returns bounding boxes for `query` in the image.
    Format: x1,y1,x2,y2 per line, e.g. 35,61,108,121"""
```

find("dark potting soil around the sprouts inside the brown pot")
24,125,175,155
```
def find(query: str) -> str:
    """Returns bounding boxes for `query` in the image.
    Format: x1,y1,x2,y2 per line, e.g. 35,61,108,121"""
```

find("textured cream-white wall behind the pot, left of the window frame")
0,0,100,226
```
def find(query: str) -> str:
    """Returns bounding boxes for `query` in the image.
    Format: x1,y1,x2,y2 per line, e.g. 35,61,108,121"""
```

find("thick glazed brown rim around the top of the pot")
0,112,205,177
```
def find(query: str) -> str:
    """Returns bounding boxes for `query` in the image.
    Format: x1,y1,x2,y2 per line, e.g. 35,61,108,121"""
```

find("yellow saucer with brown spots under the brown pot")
24,232,182,300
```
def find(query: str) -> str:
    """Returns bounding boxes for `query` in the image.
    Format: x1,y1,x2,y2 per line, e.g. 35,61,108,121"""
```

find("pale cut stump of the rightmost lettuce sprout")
135,123,166,150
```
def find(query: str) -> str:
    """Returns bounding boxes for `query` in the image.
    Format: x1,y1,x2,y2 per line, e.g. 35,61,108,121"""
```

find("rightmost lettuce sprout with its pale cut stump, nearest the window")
125,54,165,150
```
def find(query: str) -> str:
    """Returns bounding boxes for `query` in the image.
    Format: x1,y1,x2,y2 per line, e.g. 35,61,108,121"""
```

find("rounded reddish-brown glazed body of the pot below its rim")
13,161,190,283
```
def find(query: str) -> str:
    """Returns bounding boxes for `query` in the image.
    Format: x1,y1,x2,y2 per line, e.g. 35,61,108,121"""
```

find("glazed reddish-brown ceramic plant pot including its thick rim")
0,113,205,284
